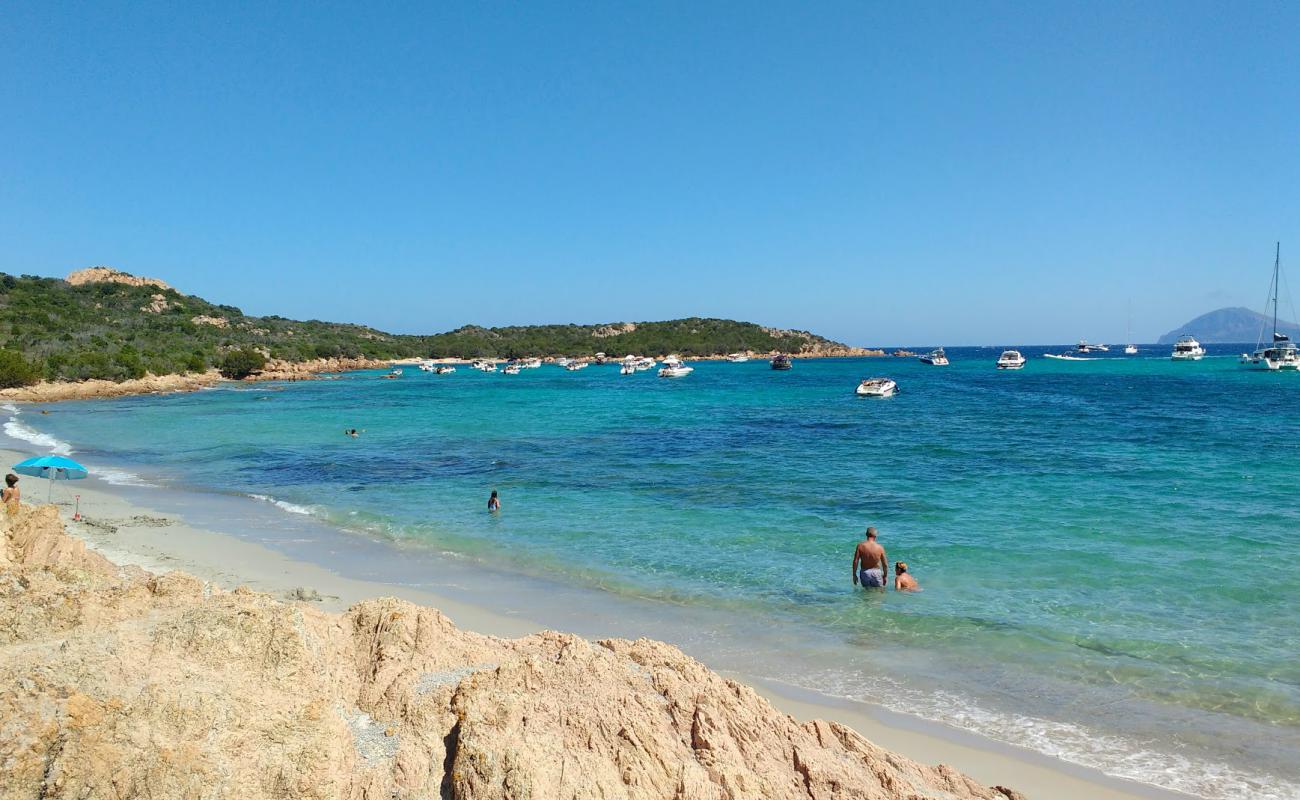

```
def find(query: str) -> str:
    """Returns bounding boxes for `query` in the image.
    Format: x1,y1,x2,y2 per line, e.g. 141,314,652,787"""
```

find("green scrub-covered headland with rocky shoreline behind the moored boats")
0,267,875,388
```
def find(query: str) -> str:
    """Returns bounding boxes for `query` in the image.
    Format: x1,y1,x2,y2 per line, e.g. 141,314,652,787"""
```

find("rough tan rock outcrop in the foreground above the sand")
0,506,1019,800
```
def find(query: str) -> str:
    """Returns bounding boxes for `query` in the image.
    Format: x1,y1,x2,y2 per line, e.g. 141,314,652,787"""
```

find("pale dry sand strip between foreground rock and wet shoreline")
0,450,1186,800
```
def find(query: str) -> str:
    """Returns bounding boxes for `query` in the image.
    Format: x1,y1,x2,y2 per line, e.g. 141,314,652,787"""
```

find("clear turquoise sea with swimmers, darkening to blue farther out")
7,347,1300,797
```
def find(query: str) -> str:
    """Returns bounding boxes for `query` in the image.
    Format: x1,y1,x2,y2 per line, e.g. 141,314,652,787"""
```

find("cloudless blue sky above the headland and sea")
0,0,1300,345
